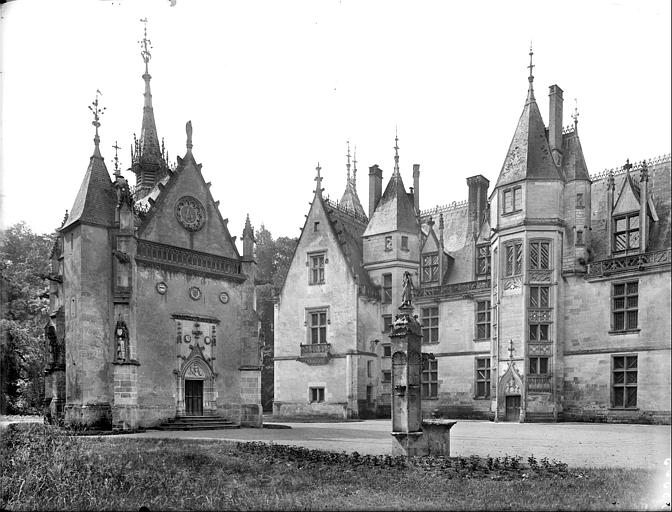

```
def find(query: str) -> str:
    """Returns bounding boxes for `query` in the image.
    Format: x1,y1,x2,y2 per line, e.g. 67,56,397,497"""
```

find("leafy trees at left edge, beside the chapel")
0,222,53,413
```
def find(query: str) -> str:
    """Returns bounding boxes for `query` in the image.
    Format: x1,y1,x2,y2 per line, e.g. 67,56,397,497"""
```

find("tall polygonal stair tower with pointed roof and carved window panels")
490,48,564,421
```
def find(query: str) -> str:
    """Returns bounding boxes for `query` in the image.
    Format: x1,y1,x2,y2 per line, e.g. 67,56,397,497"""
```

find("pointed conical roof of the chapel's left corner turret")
60,141,117,231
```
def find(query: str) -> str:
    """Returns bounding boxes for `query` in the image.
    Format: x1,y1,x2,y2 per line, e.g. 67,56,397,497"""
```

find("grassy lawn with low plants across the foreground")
0,425,657,510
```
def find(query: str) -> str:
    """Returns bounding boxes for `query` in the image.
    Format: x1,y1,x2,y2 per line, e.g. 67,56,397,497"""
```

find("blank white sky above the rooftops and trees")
0,0,672,246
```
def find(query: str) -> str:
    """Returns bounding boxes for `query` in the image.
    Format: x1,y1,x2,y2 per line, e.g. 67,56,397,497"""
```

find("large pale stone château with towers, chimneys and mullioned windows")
275,53,671,423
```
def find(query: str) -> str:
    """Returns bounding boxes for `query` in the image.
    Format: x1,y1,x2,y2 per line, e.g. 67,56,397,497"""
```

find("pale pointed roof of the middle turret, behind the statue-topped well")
363,171,418,236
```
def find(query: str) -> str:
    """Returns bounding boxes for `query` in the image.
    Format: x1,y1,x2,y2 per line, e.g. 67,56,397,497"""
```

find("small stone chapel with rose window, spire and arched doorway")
45,32,261,429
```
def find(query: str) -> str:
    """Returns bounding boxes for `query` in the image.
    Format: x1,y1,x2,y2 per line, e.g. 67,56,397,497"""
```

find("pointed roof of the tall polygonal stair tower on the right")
495,87,562,187
